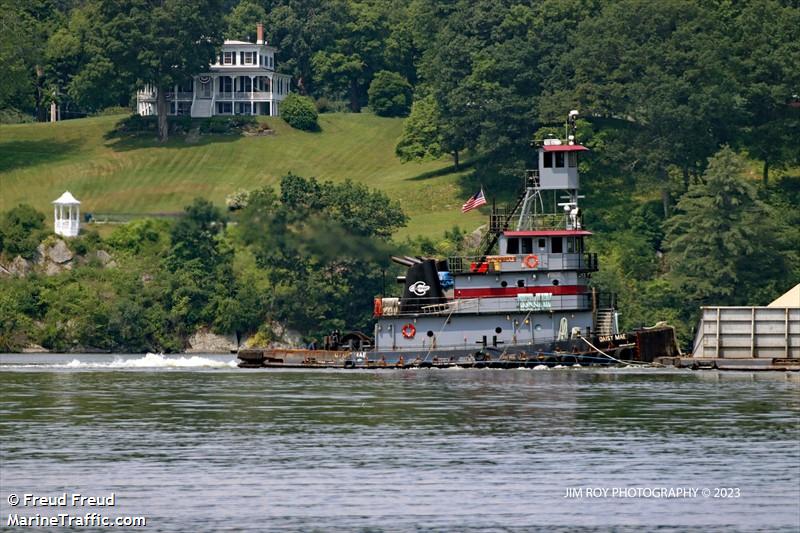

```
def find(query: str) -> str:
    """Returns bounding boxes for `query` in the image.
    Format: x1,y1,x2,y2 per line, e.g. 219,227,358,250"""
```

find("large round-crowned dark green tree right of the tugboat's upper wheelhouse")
564,0,739,216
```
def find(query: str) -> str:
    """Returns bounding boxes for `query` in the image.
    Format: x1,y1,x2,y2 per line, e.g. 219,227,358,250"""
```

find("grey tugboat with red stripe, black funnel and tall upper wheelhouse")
238,111,678,368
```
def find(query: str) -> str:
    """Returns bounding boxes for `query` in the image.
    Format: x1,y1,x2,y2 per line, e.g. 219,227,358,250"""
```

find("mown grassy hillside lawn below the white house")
0,113,483,236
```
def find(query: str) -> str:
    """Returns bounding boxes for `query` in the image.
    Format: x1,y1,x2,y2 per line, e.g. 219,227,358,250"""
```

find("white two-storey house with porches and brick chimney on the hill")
136,24,292,117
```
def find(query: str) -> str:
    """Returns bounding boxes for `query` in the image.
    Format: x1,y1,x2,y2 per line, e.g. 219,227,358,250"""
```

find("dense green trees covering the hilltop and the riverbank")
0,0,800,350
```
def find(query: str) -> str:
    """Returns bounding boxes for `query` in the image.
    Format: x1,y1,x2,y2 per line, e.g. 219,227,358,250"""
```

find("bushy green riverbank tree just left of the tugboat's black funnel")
238,175,406,335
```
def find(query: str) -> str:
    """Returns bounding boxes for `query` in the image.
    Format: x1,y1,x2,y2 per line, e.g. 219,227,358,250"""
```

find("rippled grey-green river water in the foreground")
0,354,800,532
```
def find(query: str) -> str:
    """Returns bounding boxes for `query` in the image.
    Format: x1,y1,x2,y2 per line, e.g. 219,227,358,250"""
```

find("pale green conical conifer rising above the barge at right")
665,147,791,309
